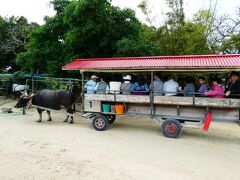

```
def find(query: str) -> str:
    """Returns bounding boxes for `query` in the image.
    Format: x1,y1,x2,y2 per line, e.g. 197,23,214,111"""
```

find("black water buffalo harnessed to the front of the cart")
15,89,79,123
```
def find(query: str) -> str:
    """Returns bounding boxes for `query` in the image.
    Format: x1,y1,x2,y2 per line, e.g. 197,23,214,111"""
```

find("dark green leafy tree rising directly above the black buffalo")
17,0,70,75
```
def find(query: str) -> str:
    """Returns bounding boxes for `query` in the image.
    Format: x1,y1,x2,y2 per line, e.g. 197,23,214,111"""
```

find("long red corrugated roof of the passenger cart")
63,54,240,71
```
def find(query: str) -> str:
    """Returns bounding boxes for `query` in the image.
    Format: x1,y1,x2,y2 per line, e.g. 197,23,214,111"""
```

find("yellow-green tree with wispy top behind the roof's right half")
154,0,212,55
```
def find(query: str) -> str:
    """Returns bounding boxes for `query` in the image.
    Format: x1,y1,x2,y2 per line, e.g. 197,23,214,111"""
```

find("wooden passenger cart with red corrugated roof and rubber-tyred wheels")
63,55,240,138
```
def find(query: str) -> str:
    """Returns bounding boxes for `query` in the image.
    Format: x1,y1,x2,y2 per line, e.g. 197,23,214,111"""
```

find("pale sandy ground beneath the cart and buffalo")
0,100,240,180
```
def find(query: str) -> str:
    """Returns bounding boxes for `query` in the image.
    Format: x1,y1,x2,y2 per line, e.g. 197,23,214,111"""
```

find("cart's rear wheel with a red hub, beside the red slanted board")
161,119,182,138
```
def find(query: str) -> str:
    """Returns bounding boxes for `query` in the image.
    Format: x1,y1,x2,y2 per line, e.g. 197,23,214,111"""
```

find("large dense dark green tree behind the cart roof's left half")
65,0,140,57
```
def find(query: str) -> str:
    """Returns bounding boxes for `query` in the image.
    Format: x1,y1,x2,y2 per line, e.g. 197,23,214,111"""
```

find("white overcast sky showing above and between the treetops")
0,0,240,26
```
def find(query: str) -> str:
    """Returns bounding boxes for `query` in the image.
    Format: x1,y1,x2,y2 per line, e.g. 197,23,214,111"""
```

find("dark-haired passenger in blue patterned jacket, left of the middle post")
131,74,149,95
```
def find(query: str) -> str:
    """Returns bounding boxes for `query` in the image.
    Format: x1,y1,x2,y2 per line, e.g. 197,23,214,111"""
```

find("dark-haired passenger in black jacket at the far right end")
225,71,240,98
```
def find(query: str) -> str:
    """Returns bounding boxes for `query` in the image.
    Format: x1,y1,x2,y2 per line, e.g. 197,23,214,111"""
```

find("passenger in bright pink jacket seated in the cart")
205,78,224,98
